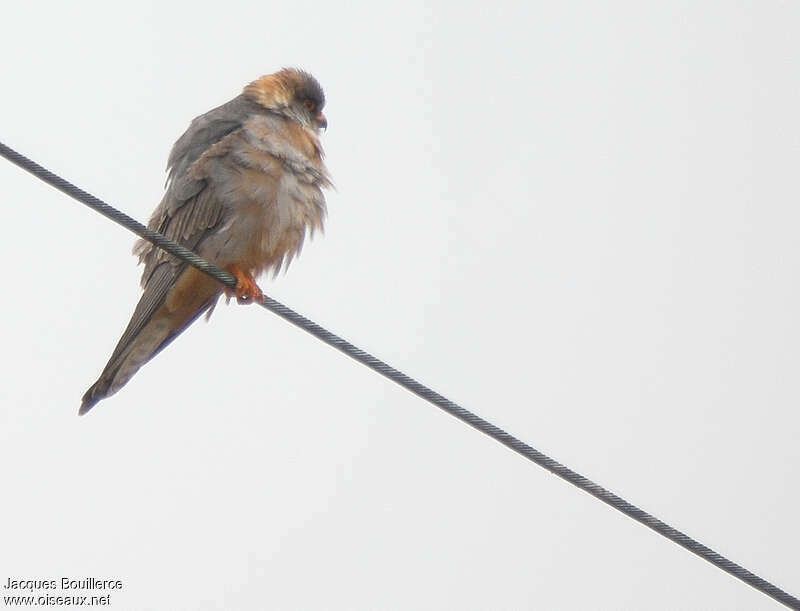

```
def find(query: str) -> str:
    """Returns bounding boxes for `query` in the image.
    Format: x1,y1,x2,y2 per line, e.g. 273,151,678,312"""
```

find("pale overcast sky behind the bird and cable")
0,1,800,610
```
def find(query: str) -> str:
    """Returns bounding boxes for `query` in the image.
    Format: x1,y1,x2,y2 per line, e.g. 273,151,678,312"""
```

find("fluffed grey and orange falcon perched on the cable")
78,68,331,414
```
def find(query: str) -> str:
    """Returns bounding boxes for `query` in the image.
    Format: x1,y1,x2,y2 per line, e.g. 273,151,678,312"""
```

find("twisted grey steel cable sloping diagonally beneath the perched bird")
0,142,800,610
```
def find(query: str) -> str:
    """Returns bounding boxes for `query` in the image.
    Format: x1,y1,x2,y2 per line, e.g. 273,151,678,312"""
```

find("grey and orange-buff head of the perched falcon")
244,68,328,132
